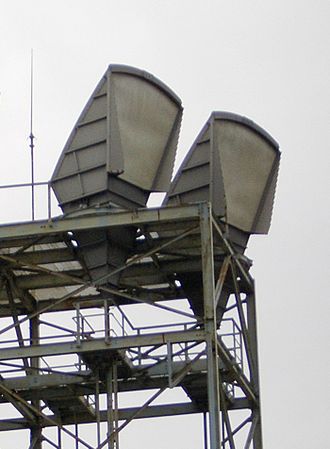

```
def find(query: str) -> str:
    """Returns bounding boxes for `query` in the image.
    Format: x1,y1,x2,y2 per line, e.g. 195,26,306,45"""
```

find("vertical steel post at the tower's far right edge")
246,285,263,449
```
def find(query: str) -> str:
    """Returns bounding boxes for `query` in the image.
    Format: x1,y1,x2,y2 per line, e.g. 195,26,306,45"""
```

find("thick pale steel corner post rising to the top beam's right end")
200,203,221,449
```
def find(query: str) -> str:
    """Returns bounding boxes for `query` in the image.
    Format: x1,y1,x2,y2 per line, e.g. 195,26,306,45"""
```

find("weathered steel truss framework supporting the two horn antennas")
0,203,262,449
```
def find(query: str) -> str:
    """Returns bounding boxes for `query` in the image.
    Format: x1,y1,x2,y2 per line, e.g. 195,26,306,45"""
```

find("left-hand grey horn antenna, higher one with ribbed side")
51,65,182,212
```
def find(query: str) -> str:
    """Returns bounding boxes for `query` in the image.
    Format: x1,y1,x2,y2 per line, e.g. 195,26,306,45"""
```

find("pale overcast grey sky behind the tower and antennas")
0,0,330,449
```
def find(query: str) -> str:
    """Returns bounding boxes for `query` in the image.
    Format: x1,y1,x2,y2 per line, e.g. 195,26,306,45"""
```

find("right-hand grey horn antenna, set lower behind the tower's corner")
165,112,280,234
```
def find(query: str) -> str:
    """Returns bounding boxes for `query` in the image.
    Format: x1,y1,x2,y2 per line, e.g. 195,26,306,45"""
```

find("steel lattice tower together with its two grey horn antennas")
0,65,280,449
